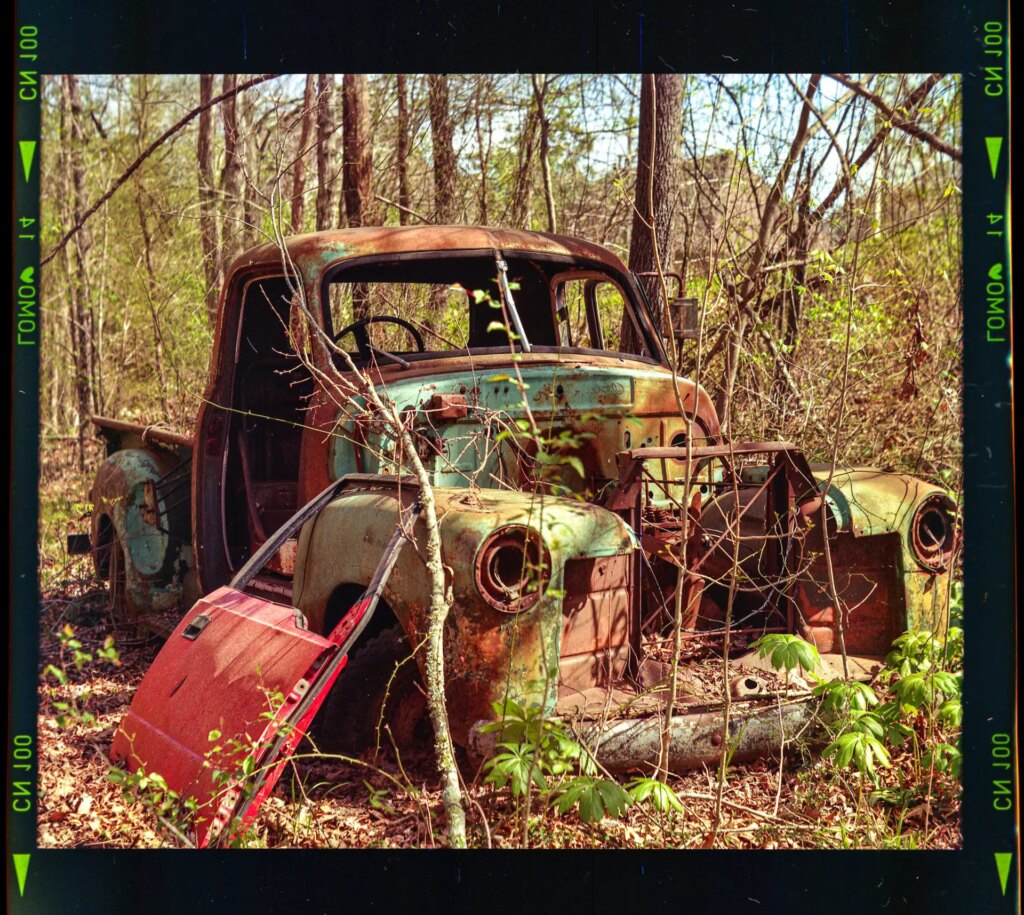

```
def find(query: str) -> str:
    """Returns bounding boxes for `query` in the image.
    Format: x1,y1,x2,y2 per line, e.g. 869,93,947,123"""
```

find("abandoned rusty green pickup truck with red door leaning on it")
81,226,956,843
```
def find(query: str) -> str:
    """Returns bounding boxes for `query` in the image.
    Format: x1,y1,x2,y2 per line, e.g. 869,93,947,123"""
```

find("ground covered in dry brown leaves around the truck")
38,450,962,848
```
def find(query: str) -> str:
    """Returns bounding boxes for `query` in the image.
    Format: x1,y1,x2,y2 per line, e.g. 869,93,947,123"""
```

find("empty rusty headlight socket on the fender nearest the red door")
475,524,551,613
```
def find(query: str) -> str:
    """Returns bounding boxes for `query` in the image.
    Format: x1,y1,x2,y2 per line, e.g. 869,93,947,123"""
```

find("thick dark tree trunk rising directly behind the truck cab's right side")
620,74,683,352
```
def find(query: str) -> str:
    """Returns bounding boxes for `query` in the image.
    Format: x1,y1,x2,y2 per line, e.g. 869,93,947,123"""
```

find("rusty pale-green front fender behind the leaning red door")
293,487,634,744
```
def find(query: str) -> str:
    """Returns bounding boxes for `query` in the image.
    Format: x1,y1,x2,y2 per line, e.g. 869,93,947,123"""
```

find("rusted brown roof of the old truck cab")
232,225,626,271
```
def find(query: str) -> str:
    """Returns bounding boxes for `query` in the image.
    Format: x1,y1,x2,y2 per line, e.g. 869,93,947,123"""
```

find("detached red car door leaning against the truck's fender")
111,479,420,847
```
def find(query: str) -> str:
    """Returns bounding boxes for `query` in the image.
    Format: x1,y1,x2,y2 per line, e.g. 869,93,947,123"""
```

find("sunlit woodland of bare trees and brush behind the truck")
40,74,963,478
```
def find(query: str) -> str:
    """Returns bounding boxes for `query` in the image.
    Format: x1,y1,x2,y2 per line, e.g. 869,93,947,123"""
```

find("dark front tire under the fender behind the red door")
313,625,430,753
